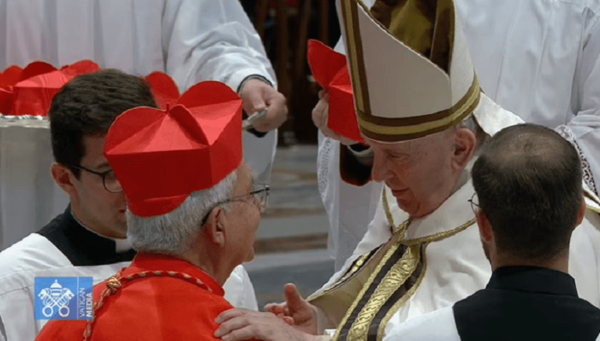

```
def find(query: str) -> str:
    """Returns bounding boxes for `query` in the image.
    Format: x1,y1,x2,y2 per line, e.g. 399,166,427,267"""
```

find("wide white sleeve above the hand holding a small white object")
162,0,276,91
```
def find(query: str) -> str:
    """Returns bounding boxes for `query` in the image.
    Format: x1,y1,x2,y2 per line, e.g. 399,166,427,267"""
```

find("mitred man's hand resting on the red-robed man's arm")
214,309,317,341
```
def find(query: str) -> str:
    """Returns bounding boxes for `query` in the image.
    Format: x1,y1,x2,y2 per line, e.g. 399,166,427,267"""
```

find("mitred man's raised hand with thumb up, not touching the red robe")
265,283,318,335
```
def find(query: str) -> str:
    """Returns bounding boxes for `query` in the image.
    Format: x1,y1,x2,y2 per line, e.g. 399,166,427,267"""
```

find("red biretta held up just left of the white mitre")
307,40,364,143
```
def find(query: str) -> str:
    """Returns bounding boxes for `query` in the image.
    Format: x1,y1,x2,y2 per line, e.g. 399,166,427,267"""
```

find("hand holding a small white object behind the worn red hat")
240,79,288,132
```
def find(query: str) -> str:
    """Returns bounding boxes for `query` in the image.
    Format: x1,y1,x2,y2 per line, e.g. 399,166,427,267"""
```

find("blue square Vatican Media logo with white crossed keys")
34,277,94,320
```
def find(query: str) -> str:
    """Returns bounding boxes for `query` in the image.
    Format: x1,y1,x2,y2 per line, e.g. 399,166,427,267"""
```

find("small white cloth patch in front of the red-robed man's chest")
223,265,258,311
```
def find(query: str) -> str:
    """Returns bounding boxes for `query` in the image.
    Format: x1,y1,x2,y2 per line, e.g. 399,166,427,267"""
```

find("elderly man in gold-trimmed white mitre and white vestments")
211,0,600,341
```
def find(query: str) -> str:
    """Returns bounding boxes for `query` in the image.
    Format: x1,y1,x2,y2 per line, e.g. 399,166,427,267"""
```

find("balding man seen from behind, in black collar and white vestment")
390,124,600,341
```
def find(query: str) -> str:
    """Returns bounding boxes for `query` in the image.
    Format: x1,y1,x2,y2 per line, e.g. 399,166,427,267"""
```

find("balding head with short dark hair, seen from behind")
472,124,583,260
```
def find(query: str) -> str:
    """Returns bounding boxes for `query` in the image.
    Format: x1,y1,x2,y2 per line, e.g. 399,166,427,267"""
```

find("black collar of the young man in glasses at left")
38,207,135,266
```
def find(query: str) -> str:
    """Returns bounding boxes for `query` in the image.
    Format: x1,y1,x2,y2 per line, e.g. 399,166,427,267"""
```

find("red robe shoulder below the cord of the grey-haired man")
91,277,233,340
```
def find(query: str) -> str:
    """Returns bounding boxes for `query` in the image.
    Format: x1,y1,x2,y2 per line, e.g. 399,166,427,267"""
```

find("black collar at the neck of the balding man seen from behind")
486,266,578,297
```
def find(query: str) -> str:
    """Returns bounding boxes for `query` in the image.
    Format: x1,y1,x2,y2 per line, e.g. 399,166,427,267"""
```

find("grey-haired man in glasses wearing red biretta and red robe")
37,77,269,340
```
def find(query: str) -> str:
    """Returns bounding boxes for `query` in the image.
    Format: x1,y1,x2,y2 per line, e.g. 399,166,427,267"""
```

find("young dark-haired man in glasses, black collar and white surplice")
0,70,256,341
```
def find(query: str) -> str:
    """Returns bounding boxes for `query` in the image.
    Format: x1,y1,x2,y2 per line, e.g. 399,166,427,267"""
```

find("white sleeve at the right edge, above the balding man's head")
558,10,600,192
